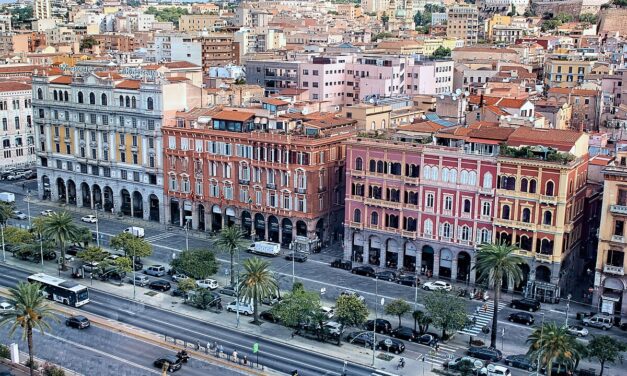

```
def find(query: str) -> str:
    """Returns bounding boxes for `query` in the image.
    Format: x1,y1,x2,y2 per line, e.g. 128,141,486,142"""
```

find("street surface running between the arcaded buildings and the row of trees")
0,182,627,376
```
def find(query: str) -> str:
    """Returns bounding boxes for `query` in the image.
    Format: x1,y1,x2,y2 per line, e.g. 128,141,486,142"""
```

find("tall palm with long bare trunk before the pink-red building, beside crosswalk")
475,242,524,347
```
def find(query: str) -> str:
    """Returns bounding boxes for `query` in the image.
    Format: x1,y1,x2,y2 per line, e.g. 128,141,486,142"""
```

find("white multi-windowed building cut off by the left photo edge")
0,81,35,170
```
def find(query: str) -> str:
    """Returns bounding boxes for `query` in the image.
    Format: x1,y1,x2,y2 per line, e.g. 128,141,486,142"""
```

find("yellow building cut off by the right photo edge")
593,150,627,315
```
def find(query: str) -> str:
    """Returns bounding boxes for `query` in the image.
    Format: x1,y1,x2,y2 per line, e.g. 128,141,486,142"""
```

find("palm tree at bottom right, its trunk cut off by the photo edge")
527,322,582,376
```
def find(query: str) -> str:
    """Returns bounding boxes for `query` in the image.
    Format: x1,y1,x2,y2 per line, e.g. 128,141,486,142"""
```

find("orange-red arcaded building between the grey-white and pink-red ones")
163,108,355,247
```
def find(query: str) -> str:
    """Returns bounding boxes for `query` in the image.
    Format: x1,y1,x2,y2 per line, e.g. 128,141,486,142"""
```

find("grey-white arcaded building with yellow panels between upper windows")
33,67,200,222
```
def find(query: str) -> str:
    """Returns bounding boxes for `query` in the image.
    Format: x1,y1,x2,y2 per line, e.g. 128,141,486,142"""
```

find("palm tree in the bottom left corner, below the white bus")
0,282,57,376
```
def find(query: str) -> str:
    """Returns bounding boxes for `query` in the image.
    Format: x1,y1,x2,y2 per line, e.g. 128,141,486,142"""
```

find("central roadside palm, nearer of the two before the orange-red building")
238,257,279,324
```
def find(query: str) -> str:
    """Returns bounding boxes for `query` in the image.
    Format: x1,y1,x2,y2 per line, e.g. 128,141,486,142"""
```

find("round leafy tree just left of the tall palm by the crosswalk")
425,290,468,339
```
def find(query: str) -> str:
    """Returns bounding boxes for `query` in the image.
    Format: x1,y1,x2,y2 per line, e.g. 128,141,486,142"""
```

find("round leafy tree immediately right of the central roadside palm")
273,288,320,328
